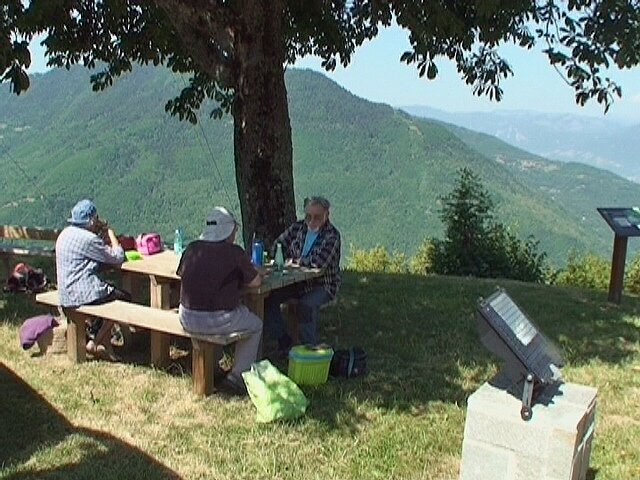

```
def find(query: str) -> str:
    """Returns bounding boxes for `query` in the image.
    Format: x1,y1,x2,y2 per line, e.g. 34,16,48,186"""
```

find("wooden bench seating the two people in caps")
36,291,248,395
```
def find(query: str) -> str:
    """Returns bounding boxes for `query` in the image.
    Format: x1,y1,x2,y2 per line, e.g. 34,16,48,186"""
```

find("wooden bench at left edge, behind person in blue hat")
0,225,61,274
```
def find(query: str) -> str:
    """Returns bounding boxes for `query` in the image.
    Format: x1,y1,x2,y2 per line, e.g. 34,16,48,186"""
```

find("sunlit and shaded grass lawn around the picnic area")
0,272,640,480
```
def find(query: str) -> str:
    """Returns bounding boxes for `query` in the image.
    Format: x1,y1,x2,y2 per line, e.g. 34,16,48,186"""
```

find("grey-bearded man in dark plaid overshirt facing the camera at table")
265,197,341,354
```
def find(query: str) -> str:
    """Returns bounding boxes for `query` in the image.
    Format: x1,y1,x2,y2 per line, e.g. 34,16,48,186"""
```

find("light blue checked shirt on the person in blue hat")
56,225,124,307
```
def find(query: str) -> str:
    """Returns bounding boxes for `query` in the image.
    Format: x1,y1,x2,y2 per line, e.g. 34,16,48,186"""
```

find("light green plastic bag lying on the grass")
242,360,309,423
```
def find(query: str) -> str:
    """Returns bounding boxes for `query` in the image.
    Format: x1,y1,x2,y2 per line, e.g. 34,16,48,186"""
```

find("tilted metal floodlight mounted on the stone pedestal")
476,289,564,421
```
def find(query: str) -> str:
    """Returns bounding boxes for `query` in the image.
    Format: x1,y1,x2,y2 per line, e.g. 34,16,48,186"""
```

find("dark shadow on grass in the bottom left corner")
0,364,181,480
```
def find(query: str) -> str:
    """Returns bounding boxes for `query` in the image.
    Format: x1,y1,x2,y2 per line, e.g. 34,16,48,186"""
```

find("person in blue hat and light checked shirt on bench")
56,199,131,359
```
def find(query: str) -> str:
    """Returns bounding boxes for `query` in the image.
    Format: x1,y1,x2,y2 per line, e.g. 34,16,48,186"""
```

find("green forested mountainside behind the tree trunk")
0,68,640,264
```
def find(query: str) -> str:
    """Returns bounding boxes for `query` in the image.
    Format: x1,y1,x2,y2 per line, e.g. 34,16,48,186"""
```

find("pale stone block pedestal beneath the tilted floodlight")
460,375,597,480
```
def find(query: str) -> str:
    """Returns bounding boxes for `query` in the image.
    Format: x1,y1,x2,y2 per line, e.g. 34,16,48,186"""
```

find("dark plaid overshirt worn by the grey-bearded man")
274,220,341,298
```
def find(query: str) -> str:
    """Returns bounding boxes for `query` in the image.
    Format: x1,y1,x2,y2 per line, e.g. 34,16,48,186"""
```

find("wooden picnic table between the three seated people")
120,250,322,360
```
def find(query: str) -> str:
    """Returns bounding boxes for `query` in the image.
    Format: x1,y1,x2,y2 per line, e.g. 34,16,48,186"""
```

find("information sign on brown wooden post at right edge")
597,207,640,303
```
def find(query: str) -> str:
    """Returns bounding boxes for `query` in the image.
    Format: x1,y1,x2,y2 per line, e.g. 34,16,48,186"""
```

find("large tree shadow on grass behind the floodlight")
305,272,640,428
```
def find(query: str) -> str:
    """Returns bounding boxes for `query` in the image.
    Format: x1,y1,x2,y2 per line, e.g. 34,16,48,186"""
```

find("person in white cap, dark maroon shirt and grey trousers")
176,207,262,395
